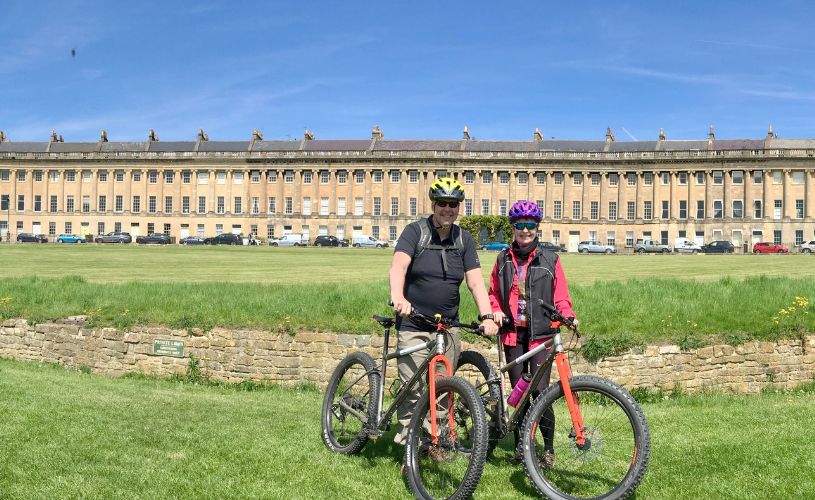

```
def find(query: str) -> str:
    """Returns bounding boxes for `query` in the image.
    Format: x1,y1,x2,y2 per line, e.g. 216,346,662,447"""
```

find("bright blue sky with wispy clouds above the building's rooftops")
0,0,815,142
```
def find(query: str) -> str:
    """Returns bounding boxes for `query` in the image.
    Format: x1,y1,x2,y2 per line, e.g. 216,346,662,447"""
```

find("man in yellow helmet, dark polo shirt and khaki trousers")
390,177,498,444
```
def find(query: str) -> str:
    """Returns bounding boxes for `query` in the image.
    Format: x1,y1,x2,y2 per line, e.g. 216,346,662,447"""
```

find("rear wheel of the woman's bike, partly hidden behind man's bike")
455,351,503,455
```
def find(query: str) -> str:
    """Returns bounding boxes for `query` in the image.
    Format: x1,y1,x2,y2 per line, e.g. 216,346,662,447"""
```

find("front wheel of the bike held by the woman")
521,375,651,499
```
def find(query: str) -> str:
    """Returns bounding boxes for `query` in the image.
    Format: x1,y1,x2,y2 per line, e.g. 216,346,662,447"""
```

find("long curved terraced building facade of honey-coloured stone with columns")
0,127,815,251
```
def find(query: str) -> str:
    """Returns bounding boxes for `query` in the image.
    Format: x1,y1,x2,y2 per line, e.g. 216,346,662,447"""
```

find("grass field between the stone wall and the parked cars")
0,245,815,355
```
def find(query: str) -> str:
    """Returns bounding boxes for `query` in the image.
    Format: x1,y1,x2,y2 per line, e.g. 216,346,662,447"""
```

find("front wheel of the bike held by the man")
404,377,488,499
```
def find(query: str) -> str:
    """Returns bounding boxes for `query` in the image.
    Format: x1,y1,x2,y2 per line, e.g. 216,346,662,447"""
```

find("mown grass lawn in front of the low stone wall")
0,360,815,499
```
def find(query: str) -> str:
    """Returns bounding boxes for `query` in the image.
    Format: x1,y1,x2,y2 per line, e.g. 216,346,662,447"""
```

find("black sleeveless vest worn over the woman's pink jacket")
497,246,558,340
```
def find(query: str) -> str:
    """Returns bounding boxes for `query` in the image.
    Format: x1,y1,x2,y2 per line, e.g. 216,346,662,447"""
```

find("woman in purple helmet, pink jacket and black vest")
489,200,575,468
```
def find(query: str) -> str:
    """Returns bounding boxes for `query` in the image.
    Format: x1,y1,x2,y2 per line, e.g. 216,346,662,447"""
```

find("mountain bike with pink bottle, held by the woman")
456,301,651,499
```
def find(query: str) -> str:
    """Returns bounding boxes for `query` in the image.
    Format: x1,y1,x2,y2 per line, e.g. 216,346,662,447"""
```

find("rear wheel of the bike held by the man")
322,352,380,455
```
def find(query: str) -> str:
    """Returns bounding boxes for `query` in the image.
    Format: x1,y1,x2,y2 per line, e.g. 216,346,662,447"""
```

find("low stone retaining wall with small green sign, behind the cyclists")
0,316,815,393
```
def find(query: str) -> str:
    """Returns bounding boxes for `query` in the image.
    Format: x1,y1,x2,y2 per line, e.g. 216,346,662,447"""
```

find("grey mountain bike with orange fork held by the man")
322,311,487,499
